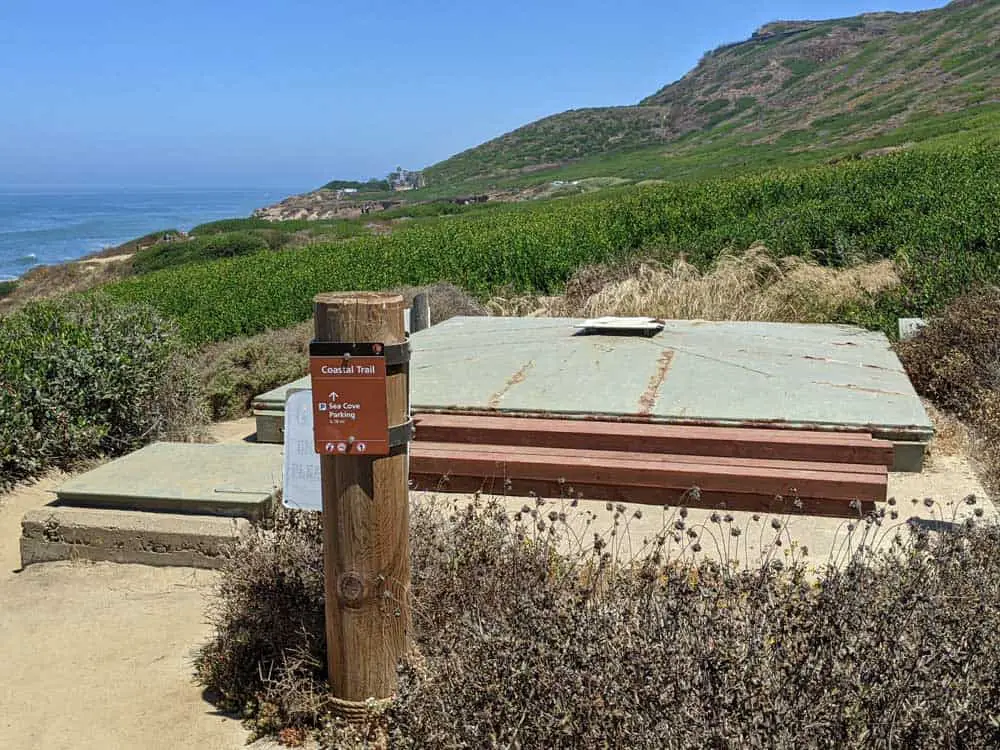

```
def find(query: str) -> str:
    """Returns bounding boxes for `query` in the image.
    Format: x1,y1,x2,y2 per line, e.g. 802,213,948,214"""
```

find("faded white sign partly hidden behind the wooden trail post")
281,390,323,510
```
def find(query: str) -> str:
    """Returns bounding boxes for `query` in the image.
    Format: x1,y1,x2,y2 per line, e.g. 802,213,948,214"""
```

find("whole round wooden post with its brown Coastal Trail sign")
310,292,410,715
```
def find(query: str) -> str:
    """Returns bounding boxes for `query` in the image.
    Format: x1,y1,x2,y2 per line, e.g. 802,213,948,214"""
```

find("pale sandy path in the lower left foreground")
0,428,259,750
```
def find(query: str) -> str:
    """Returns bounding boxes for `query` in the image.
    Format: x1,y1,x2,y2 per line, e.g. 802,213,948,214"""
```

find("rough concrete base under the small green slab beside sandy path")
21,506,250,568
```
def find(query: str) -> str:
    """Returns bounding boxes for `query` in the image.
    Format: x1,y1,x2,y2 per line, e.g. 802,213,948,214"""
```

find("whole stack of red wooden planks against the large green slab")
410,414,893,517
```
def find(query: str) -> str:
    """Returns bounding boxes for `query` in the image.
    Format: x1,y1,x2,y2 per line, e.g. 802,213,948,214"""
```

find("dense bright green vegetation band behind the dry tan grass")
99,141,1000,342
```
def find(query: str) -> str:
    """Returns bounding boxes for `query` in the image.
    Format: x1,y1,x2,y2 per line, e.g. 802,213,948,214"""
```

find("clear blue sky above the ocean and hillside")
0,0,943,190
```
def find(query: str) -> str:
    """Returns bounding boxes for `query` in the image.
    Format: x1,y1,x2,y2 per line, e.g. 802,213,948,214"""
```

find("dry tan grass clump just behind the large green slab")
488,245,900,323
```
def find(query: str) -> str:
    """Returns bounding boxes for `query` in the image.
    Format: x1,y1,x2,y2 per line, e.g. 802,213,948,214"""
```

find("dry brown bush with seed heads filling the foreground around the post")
198,498,1000,750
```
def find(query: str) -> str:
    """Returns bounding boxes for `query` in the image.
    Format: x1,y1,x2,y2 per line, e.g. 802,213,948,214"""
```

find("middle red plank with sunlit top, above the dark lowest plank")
410,443,886,500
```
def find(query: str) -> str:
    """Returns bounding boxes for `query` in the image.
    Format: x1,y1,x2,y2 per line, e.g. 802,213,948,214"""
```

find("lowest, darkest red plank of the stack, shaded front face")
410,471,875,518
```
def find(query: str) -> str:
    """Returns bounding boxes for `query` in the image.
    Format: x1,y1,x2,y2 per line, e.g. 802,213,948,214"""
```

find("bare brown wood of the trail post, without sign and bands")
314,292,410,704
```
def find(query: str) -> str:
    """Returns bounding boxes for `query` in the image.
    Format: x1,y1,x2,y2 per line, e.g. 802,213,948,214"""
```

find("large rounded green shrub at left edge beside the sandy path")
0,299,202,489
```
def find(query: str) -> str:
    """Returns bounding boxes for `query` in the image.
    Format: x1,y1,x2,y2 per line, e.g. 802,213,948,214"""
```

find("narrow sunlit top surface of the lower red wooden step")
417,442,888,477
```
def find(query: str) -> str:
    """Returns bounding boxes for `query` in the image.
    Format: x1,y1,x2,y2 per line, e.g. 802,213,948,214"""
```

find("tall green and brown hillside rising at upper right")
424,0,1000,192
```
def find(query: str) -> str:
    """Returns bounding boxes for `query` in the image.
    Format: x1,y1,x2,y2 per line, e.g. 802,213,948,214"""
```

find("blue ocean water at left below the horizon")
0,186,304,280
